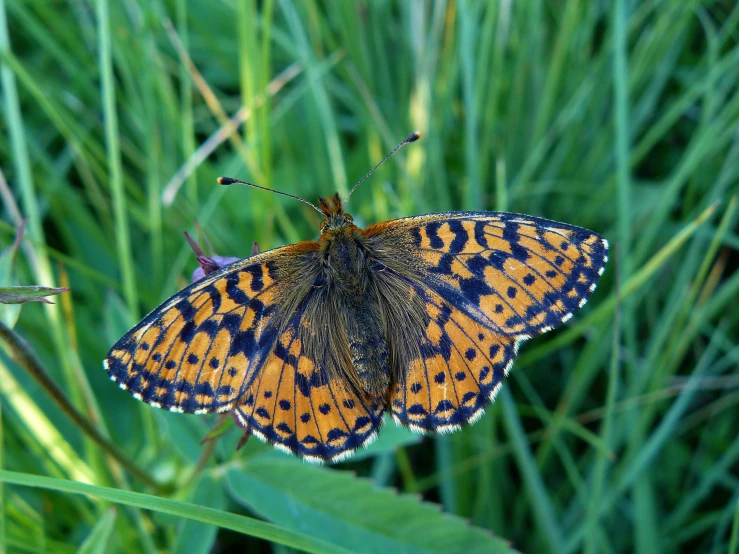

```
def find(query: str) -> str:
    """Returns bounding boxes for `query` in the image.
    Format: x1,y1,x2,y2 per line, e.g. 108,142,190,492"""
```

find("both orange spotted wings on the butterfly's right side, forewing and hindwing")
365,212,608,432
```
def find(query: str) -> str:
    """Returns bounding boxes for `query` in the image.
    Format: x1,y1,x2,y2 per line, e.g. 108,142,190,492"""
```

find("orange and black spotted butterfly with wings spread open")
103,133,608,462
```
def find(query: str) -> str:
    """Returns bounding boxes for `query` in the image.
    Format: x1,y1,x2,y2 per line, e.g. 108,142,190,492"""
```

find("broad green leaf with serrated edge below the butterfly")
226,454,511,554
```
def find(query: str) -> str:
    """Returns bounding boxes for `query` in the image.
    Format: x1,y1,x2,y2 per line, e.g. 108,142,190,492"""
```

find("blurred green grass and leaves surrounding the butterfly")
0,0,739,553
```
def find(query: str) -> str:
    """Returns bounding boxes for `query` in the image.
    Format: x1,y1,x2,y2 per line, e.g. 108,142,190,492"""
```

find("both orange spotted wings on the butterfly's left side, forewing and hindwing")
104,239,383,461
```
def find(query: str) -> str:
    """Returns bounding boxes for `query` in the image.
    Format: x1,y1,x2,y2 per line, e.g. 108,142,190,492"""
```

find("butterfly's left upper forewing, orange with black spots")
103,243,315,414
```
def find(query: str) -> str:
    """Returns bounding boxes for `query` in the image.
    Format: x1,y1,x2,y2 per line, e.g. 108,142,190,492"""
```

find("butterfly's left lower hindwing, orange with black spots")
234,317,384,462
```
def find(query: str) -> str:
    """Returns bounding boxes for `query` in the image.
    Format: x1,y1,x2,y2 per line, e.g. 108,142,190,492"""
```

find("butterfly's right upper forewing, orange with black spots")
365,212,608,338
